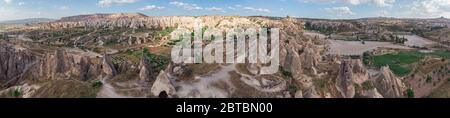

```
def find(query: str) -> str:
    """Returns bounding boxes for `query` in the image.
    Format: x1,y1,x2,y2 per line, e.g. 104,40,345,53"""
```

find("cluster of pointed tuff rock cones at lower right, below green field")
336,59,406,98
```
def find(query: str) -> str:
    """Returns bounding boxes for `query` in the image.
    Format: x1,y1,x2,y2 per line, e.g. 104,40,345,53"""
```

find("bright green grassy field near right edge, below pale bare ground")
364,51,450,76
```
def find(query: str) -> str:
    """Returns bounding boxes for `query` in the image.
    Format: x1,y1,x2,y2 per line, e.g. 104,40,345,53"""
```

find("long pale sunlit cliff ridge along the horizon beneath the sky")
36,13,268,29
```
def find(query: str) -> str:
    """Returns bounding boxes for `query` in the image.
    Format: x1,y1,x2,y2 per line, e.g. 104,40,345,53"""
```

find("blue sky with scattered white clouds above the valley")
0,0,450,21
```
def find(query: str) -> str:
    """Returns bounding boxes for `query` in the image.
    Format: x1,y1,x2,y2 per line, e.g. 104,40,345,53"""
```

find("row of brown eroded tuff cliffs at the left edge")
0,44,134,86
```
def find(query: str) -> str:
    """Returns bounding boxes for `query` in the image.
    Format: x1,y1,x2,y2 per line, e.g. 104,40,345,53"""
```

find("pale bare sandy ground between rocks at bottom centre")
173,64,286,98
